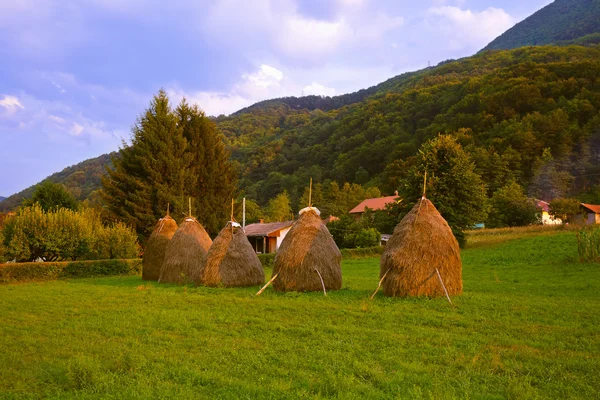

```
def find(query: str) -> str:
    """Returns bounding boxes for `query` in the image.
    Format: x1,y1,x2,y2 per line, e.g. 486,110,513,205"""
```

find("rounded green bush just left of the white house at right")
486,181,538,228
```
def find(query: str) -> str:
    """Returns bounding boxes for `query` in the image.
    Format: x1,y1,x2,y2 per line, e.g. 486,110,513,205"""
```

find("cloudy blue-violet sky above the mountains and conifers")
0,0,551,196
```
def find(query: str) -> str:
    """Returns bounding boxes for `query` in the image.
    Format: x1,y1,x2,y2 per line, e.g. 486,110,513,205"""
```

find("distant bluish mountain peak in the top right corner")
483,0,600,50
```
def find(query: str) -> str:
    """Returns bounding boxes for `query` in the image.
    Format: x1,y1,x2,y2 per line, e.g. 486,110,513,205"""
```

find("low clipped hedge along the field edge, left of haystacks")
0,259,142,283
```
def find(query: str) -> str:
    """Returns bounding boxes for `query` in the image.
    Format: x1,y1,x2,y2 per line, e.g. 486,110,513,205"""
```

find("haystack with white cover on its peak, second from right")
273,210,342,292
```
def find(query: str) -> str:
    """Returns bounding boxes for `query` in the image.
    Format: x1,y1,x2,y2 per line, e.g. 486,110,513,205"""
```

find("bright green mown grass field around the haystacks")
0,231,600,399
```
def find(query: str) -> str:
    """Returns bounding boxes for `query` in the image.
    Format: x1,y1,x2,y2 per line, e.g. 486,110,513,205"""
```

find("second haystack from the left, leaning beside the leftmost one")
158,217,212,283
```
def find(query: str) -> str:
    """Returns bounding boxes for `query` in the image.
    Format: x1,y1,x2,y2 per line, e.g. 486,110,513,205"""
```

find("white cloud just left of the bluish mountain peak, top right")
427,6,516,50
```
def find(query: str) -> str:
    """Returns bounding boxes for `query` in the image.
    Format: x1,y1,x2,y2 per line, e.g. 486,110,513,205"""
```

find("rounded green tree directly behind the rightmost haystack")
400,135,487,245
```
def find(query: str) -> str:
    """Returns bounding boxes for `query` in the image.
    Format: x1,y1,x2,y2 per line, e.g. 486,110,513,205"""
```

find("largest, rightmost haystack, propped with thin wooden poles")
379,198,462,297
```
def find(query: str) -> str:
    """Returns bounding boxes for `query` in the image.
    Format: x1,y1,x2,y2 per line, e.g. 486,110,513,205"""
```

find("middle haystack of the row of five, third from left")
202,224,265,287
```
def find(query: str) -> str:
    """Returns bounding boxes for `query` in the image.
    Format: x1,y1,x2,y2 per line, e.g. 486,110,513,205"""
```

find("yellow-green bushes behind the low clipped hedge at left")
3,203,139,261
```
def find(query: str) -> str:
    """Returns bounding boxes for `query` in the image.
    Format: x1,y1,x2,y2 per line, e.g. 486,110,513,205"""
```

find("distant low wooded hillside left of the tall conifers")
0,152,117,211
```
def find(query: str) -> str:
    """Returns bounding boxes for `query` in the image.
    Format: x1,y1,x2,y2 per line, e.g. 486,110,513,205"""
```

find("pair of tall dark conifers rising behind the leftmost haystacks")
102,90,235,237
